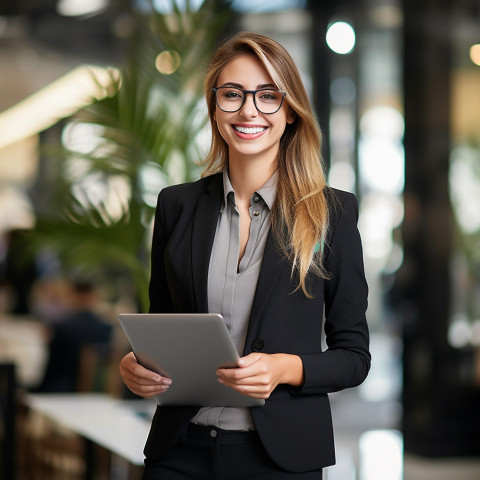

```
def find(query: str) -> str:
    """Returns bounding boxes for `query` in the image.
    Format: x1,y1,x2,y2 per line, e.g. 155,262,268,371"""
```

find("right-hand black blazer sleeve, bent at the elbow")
297,192,371,394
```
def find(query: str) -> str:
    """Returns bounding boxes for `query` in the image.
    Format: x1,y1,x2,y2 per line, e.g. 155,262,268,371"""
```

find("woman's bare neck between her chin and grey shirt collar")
228,159,276,203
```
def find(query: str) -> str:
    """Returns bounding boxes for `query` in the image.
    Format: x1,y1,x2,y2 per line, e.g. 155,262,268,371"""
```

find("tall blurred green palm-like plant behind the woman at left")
33,0,231,310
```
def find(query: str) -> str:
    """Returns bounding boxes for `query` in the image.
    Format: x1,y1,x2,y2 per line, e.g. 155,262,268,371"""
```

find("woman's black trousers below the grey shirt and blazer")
143,424,322,480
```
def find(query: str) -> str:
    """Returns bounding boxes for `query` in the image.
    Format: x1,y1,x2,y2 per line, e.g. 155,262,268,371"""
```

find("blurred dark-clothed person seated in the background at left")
36,279,113,392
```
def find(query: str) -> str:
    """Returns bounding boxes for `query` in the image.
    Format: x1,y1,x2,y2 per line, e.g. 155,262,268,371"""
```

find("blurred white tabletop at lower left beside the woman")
24,393,155,474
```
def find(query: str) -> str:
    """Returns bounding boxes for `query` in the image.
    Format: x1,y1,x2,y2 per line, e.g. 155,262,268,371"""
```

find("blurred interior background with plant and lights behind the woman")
0,0,480,480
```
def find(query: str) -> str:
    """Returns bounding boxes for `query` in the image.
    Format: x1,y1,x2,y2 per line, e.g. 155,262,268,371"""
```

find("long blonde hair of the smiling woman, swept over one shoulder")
202,32,328,298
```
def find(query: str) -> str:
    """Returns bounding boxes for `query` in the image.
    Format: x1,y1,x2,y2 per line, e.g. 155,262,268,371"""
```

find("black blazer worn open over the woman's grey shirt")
145,174,370,472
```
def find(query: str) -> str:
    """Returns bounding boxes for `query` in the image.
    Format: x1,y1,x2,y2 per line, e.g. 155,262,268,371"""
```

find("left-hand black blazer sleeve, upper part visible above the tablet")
149,189,173,313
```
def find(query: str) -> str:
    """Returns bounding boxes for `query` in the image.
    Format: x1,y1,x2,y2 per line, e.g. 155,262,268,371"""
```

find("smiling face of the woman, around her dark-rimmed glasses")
214,55,295,167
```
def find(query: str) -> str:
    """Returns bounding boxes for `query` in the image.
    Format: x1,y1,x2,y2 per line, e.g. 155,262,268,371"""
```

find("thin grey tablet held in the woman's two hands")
119,313,265,407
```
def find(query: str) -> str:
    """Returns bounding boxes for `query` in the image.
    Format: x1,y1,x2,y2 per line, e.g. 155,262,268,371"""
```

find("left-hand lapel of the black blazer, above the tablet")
192,174,223,313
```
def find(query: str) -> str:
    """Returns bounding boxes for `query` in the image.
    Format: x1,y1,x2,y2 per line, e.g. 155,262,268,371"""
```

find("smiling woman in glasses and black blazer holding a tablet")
120,33,370,480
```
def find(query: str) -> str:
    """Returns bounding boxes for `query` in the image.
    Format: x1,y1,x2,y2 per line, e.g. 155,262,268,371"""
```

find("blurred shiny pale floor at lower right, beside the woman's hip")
324,394,480,480
